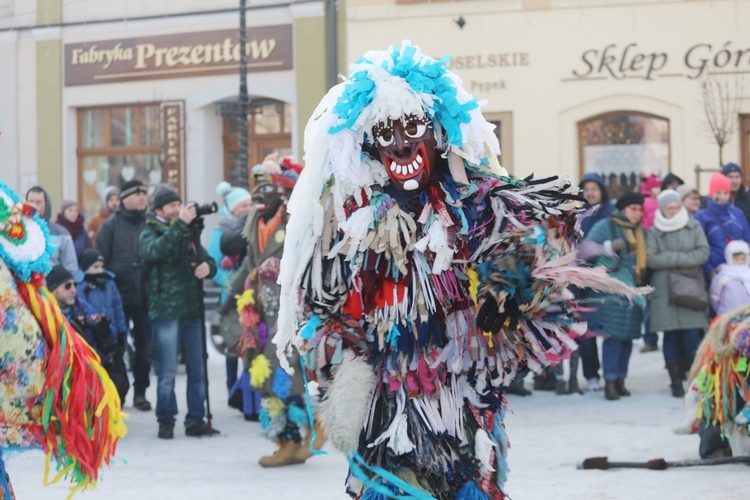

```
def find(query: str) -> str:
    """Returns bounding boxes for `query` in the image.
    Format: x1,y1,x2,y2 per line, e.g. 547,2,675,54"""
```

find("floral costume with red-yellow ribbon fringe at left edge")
0,181,126,500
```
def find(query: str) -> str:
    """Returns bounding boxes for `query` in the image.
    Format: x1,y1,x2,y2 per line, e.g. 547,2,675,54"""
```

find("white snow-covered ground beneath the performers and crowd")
7,334,750,500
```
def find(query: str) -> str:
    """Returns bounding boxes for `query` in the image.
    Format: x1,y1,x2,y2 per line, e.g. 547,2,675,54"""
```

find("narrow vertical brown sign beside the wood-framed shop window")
161,101,187,198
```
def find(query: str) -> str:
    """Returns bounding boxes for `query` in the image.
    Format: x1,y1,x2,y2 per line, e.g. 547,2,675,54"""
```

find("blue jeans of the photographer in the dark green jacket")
152,318,206,427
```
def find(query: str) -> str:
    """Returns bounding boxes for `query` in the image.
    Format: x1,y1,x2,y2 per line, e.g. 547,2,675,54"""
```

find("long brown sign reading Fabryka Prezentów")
65,24,292,86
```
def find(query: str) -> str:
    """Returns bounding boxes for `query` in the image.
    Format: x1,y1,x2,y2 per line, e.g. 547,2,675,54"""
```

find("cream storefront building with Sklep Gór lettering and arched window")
346,0,750,196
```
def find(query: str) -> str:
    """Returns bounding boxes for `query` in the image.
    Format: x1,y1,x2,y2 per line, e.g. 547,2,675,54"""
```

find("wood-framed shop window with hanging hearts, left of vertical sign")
78,104,164,220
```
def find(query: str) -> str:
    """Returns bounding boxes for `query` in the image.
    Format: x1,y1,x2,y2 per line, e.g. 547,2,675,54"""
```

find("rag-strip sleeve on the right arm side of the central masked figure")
470,177,637,372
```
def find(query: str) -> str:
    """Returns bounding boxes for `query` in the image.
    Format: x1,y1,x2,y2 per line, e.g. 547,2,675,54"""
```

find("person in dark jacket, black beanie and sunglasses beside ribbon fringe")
46,266,129,404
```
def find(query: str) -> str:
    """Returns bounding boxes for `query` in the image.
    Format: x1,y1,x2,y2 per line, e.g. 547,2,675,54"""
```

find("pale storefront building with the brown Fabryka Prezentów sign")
0,0,327,227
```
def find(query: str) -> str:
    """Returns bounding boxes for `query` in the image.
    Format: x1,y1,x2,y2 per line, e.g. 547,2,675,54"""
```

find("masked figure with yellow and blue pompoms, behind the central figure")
233,157,323,467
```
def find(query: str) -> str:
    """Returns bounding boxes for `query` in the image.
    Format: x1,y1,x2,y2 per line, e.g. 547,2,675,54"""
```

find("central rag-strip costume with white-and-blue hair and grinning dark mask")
274,43,648,499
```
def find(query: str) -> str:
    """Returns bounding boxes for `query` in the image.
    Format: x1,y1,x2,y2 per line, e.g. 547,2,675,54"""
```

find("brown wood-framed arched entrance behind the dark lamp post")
220,99,294,187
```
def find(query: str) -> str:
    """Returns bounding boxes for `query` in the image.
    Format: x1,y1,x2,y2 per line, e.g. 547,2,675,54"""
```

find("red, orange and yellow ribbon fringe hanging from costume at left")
17,277,127,496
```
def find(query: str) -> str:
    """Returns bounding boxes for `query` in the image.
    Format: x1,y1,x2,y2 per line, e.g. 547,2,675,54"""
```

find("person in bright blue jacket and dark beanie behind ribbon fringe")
76,248,130,401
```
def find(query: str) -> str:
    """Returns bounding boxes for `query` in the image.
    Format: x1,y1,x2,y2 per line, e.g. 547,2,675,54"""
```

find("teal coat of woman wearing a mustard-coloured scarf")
586,210,646,340
